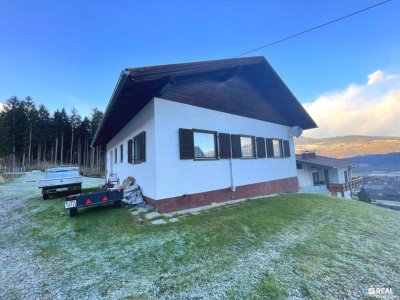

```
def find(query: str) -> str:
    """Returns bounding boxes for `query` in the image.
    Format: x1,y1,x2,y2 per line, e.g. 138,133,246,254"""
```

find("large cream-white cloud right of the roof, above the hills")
304,70,400,138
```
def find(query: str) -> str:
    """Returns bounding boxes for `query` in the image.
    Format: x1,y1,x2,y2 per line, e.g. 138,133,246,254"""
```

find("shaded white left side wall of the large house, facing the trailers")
106,101,156,199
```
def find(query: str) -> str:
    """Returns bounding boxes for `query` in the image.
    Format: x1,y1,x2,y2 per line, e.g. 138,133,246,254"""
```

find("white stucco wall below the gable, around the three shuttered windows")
153,98,297,199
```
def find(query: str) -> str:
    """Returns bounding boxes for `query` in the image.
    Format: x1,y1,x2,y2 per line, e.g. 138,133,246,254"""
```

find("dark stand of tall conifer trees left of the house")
0,96,105,174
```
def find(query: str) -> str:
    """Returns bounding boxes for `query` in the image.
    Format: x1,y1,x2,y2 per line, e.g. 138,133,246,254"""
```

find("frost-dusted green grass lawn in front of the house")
0,176,400,299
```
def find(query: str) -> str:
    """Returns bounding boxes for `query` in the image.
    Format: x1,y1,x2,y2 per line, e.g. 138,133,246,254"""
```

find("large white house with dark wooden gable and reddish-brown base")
93,57,316,211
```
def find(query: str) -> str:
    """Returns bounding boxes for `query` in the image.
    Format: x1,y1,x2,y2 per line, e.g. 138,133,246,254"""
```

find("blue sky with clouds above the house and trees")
0,0,400,137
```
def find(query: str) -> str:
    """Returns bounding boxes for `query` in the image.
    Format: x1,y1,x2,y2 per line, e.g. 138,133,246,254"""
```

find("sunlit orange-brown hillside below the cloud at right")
295,135,400,158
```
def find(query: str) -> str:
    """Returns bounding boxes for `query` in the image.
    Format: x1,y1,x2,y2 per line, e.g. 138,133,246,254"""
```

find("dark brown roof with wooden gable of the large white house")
93,56,317,146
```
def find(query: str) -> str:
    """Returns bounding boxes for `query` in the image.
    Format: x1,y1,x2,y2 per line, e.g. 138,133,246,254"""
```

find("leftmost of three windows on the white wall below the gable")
193,131,217,159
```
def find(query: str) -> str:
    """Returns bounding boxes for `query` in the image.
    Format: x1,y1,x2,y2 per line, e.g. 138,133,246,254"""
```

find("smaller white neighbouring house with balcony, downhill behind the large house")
296,152,363,199
